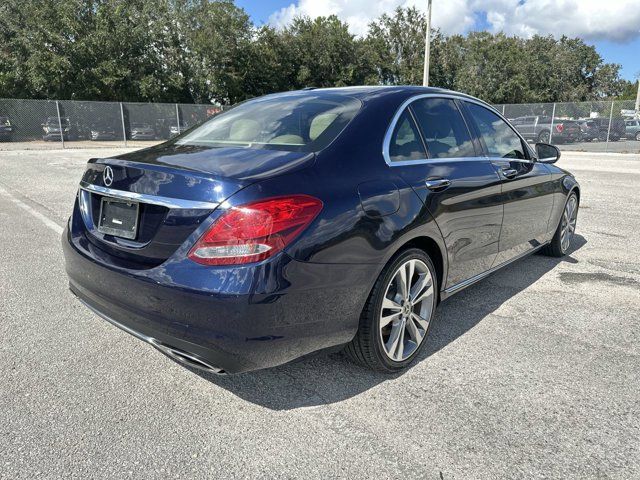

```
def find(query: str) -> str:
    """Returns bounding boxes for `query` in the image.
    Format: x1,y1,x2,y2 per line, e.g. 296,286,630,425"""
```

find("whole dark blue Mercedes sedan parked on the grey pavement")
62,87,580,373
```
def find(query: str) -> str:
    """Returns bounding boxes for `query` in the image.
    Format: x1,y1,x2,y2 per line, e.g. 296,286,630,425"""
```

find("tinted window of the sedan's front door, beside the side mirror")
467,102,526,158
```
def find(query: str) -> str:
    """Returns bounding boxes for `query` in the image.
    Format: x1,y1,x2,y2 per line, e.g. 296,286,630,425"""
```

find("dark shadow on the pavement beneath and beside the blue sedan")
189,235,587,410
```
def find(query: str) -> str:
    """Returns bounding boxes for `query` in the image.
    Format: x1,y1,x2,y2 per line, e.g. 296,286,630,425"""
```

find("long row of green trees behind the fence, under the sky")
0,0,633,104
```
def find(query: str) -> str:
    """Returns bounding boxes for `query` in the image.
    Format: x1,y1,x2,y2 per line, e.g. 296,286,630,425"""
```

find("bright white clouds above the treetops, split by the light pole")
269,0,640,42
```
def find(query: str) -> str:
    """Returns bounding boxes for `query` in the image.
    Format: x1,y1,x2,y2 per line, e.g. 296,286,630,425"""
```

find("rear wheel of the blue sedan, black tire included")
345,248,438,373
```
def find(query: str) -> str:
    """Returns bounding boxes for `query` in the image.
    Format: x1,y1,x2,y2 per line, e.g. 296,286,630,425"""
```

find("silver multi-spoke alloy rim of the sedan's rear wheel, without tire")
379,259,435,362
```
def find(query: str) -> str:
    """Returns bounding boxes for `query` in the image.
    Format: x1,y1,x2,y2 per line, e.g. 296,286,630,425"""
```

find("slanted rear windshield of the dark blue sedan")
175,93,361,152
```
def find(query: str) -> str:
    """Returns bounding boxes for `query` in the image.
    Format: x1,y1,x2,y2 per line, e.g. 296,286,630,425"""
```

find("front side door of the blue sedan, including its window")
463,101,553,266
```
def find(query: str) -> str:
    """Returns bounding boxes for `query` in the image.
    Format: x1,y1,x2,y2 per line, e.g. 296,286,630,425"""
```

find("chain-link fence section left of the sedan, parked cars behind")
0,99,222,149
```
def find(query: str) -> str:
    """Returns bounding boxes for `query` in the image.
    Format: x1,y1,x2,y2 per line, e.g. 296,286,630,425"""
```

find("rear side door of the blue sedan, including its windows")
385,95,502,288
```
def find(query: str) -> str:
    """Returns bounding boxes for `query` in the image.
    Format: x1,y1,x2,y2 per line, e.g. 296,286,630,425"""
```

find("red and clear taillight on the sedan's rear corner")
189,195,322,265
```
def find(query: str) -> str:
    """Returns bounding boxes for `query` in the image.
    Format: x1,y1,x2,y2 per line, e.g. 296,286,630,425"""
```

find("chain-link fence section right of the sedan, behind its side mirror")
494,100,640,153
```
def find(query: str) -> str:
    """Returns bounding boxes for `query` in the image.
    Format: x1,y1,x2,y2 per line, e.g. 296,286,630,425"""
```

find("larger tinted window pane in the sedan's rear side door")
411,98,476,158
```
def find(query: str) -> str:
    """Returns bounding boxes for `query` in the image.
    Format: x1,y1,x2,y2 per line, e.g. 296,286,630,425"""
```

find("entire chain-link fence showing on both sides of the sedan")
0,95,640,153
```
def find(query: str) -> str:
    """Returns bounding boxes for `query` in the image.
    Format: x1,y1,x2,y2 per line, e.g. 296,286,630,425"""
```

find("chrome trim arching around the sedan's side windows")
382,93,536,167
